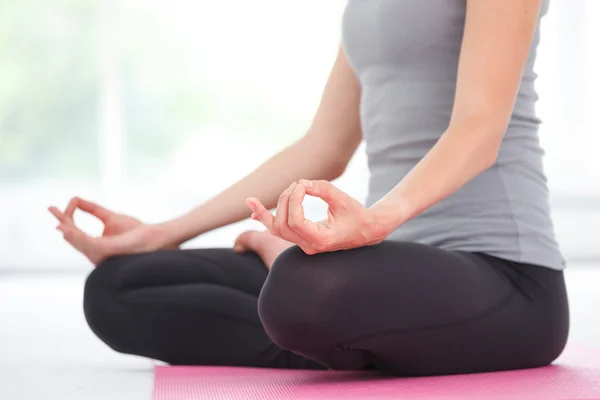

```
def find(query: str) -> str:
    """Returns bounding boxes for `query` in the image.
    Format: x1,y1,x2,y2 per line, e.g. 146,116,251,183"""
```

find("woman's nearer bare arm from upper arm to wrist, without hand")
372,0,540,227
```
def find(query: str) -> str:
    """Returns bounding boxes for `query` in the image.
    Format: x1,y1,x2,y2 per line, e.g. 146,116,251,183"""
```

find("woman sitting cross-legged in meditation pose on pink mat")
51,0,569,375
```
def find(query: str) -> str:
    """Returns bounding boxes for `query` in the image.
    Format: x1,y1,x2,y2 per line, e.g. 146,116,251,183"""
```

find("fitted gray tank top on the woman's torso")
343,0,565,269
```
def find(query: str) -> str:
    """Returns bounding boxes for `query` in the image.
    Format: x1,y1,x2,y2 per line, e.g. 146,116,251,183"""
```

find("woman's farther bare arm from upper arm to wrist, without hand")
159,48,362,244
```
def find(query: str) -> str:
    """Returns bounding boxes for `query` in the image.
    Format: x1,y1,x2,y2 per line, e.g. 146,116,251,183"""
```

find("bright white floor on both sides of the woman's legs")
0,265,600,400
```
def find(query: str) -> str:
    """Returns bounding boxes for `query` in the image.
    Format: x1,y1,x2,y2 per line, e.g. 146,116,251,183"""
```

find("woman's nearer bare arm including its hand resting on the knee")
249,0,541,254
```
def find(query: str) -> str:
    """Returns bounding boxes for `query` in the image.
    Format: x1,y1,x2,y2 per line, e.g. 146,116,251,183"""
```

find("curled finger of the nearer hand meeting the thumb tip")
288,185,332,247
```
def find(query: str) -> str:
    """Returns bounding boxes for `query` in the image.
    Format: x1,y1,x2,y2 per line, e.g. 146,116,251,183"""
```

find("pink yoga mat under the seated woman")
154,346,600,400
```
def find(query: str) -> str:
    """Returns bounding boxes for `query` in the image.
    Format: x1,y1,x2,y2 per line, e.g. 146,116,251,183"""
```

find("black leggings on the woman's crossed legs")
84,242,569,376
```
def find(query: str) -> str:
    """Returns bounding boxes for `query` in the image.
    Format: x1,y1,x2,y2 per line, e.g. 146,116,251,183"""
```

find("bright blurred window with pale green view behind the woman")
0,0,600,269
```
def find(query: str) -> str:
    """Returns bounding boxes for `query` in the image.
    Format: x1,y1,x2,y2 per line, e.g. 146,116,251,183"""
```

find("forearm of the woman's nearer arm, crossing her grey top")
371,122,502,231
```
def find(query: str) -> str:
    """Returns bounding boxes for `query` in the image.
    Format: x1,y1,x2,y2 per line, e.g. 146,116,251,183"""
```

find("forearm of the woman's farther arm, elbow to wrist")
160,138,341,244
